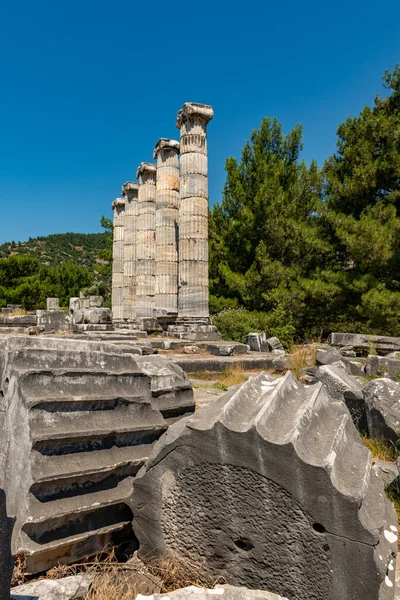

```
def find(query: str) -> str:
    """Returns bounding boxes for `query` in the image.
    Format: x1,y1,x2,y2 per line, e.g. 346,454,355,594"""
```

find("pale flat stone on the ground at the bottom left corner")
11,575,92,600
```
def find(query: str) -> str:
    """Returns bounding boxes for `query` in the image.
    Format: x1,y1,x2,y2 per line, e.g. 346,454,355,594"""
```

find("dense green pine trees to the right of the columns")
210,67,400,337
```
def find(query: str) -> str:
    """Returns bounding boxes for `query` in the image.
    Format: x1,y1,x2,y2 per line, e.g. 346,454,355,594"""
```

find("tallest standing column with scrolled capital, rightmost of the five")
176,102,214,323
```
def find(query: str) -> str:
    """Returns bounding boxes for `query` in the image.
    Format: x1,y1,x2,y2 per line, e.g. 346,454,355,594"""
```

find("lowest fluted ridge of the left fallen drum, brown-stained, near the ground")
21,518,132,574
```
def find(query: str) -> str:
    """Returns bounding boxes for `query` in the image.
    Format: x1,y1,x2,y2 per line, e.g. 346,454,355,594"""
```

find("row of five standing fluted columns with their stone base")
112,102,221,340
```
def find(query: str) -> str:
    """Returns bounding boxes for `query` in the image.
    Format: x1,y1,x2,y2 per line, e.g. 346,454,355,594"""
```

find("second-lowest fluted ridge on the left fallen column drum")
28,475,133,532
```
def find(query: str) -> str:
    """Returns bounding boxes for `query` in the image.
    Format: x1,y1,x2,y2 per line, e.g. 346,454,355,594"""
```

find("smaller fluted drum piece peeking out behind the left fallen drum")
136,356,196,423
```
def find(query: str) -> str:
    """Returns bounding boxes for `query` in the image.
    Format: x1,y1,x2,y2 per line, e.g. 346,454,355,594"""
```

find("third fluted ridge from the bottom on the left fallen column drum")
31,442,154,490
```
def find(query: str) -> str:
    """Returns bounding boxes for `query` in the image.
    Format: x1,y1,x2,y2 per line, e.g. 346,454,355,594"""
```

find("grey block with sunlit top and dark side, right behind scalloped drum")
316,364,368,432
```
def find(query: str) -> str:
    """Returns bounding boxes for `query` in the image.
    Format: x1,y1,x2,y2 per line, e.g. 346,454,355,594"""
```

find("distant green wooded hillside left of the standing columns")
0,233,107,269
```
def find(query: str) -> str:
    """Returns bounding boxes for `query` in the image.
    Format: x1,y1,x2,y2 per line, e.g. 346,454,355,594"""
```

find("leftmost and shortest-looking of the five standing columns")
111,198,125,323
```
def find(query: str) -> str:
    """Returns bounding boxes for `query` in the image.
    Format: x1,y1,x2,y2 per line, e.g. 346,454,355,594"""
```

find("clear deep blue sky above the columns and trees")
0,0,400,243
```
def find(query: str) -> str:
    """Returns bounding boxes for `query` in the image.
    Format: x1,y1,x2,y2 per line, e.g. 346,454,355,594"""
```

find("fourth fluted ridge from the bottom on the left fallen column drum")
30,404,165,444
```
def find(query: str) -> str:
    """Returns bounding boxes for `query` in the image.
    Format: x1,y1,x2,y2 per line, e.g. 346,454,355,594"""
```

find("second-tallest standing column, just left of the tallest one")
154,138,180,316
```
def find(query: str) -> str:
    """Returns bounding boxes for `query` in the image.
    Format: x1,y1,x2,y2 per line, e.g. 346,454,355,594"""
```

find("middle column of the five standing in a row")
136,162,157,318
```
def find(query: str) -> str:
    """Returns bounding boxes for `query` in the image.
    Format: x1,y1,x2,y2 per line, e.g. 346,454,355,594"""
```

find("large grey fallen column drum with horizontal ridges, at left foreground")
0,336,167,573
